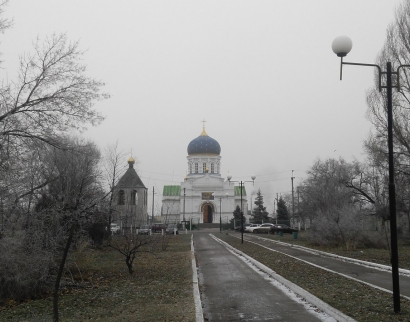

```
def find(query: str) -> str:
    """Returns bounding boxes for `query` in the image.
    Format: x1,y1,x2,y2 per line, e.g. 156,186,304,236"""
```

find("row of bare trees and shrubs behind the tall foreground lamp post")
286,0,410,248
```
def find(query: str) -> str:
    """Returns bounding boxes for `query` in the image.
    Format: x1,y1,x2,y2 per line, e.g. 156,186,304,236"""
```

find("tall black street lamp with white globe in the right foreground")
332,36,402,313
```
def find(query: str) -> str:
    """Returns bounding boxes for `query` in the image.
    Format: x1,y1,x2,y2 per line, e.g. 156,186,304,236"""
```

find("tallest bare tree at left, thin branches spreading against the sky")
0,32,108,229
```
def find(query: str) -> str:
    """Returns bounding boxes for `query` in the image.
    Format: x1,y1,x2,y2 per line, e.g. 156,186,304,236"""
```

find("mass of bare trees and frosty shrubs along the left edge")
0,1,119,312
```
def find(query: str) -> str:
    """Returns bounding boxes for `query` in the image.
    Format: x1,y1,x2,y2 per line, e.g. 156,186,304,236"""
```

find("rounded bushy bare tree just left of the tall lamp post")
299,158,370,249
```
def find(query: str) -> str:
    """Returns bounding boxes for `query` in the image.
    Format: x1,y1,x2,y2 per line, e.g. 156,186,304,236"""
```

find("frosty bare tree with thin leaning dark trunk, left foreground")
42,139,104,321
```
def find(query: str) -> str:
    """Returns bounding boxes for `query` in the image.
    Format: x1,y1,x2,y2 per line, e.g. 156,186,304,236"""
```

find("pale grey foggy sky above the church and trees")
0,0,400,214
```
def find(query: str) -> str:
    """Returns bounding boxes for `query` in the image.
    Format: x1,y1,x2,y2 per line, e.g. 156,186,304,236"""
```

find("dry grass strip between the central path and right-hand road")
217,234,410,322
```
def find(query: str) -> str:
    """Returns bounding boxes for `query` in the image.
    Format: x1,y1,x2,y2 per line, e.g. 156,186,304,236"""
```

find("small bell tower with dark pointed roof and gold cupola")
112,157,148,227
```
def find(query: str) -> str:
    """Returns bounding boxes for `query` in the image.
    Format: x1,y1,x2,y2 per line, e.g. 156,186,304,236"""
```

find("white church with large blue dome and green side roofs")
161,126,248,223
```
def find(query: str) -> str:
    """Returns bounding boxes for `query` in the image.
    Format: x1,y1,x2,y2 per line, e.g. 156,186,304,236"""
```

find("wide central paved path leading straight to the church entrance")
194,231,334,322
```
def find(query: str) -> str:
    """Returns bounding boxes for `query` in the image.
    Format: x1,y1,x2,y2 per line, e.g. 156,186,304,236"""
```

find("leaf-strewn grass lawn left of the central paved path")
0,234,195,322
